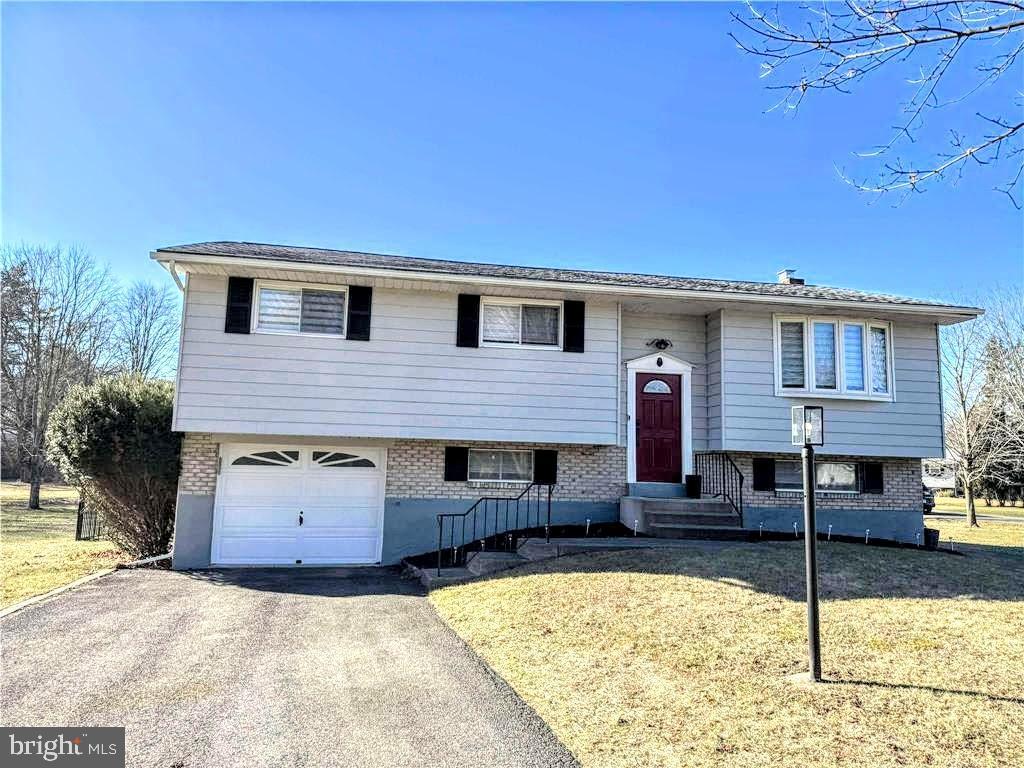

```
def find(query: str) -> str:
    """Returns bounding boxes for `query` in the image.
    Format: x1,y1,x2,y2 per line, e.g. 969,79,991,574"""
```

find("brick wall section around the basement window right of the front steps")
729,452,922,510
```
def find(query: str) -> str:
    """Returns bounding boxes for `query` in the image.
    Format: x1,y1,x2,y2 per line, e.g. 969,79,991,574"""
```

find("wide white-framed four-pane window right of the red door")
774,315,893,400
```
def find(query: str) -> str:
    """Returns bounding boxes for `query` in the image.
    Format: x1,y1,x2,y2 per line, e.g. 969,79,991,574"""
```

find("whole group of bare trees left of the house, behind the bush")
0,245,179,509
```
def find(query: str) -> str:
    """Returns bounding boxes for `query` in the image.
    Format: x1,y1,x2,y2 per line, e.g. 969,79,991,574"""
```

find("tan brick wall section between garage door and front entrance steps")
385,440,626,502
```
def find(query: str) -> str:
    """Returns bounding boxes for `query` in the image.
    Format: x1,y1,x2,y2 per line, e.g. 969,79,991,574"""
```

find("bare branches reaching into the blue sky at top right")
730,0,1024,208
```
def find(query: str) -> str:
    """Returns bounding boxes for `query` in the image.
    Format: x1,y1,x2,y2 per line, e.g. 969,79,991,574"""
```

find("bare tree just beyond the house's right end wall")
941,303,1013,525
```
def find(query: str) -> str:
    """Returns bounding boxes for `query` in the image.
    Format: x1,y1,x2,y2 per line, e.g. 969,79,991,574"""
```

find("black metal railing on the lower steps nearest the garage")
437,482,554,575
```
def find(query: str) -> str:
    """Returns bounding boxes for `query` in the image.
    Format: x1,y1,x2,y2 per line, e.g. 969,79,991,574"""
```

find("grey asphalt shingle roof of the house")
157,242,978,308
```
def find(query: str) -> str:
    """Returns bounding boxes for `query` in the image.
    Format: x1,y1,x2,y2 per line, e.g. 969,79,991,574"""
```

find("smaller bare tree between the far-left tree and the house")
114,281,178,378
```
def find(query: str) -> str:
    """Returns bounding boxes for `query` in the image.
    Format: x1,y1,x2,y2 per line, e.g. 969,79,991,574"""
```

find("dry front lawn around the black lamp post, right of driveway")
431,522,1024,768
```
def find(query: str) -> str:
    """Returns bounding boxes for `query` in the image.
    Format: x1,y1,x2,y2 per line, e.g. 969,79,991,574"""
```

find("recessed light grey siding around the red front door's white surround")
620,311,708,451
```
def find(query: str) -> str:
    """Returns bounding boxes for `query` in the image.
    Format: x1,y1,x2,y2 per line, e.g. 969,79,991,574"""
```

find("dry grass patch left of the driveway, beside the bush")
0,482,123,607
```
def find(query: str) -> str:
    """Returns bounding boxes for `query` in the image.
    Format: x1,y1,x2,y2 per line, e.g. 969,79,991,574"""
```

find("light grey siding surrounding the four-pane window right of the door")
722,310,942,458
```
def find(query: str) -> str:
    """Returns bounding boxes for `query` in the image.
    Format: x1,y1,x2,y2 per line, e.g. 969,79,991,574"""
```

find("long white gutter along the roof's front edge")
150,251,982,319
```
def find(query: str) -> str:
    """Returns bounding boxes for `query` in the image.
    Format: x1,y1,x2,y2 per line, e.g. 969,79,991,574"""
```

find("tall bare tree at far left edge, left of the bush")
0,245,113,509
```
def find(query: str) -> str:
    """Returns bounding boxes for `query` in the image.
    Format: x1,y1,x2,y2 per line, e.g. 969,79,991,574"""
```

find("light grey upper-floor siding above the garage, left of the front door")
175,274,616,444
